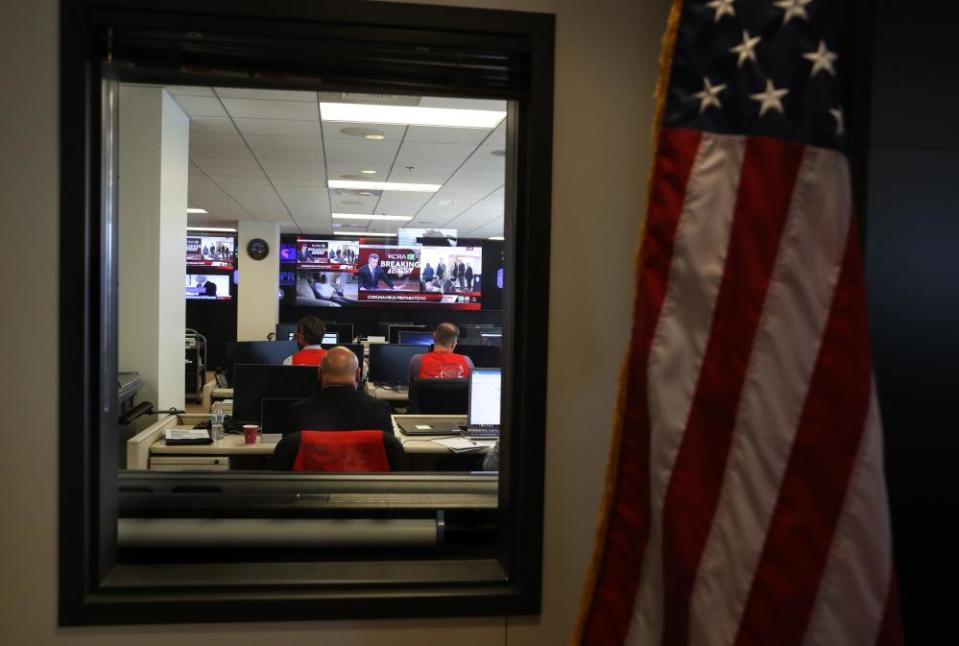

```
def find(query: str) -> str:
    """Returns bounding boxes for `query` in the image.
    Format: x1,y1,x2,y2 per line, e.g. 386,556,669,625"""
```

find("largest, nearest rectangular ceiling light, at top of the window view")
320,103,506,129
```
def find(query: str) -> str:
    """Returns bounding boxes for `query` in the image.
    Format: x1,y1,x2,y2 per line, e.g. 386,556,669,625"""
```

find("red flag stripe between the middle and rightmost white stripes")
735,224,871,646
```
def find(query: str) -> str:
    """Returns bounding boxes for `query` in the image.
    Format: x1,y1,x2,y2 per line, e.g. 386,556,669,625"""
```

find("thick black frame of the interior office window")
59,0,554,626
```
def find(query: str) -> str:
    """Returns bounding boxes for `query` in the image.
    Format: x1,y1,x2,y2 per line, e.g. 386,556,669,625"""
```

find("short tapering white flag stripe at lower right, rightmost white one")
803,388,892,646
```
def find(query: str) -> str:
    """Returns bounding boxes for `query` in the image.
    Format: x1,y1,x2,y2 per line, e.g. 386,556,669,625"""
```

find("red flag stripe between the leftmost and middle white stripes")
662,137,804,645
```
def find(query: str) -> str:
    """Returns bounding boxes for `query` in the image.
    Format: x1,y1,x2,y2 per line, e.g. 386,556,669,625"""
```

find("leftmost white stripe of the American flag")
628,133,745,643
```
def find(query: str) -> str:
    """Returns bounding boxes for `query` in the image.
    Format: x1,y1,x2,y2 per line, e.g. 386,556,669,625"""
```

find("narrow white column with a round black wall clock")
236,220,280,341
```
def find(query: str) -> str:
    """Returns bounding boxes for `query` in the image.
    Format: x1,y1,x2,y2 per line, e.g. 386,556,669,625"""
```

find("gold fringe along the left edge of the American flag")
569,0,683,646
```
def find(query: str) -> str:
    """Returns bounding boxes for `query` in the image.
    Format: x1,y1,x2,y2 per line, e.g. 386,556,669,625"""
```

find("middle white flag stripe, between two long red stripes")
690,148,851,646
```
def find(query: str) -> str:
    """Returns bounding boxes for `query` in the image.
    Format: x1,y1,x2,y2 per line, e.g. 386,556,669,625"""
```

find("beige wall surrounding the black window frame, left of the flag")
0,0,669,646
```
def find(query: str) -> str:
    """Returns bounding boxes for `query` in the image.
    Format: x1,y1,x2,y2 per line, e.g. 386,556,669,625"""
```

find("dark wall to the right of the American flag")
865,0,959,644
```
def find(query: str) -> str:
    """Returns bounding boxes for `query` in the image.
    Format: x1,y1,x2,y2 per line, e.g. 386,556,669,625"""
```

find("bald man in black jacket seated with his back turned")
272,346,406,471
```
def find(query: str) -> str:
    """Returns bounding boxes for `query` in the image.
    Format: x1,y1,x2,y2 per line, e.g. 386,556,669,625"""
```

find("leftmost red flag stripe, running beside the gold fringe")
582,128,702,644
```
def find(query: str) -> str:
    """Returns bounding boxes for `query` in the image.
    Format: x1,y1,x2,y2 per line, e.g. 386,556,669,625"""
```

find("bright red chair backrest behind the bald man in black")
293,431,390,472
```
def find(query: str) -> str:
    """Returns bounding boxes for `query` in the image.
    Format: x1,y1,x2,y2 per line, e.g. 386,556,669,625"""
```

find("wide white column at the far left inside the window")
117,86,190,408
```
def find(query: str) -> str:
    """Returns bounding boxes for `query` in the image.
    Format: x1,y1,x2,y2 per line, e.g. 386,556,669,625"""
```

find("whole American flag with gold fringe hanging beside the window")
575,0,901,646
